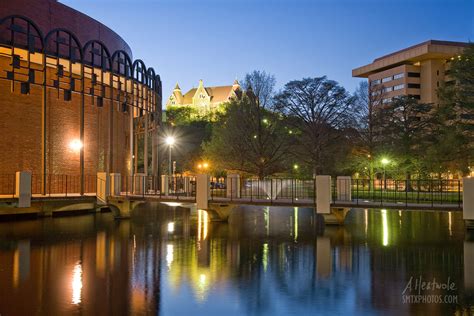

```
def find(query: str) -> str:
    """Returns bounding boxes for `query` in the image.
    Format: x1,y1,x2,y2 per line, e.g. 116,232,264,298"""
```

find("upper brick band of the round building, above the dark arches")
0,0,132,58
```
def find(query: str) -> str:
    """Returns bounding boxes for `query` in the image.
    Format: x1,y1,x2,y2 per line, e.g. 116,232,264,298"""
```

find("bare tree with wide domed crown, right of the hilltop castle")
275,77,354,175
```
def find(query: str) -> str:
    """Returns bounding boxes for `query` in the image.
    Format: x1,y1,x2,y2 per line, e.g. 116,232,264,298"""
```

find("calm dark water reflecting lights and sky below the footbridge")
0,204,474,316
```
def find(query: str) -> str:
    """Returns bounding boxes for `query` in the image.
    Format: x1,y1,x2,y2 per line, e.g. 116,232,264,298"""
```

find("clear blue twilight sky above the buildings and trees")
60,0,474,104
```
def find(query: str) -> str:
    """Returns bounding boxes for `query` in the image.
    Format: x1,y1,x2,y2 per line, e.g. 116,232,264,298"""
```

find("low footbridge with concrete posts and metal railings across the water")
0,172,474,226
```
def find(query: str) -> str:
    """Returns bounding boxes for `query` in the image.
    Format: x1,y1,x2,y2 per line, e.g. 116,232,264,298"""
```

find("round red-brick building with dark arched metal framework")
0,0,162,193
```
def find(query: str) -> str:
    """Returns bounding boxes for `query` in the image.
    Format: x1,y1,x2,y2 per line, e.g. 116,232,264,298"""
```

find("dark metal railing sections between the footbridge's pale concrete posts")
0,174,463,208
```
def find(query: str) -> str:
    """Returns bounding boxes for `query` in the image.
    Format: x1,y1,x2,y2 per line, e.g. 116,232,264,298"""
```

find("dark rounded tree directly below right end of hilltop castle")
203,90,290,179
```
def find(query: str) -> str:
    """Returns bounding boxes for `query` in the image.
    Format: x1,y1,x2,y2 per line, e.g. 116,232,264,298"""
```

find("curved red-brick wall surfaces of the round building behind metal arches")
0,0,161,193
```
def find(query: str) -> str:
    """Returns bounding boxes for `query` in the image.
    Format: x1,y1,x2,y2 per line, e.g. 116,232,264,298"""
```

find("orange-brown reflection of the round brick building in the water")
0,216,135,315
